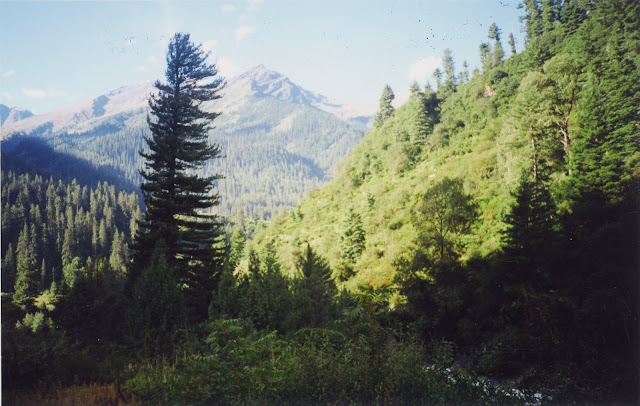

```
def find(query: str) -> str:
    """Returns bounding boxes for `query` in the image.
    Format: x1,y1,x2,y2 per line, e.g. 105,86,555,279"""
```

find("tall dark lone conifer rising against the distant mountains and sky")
133,33,224,314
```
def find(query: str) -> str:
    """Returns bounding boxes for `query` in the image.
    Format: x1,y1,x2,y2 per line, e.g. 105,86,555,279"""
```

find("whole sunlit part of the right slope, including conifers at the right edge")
258,3,640,286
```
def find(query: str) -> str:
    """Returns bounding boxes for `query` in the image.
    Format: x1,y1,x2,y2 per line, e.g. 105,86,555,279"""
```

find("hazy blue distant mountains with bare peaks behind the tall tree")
0,65,374,218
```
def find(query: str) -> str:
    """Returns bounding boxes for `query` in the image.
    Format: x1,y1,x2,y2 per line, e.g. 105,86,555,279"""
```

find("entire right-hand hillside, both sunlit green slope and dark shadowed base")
248,1,640,396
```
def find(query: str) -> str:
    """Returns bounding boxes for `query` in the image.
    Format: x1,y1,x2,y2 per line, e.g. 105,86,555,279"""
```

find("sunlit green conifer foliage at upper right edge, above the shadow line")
569,1,640,203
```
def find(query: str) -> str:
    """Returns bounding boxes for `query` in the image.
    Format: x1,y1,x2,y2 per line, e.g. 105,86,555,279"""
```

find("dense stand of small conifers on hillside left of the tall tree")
2,172,140,292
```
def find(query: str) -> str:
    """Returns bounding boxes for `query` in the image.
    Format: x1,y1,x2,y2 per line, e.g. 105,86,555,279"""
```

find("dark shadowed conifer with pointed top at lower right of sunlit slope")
498,170,567,362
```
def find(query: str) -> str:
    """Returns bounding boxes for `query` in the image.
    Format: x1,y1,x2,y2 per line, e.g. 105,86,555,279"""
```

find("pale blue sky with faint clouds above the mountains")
0,0,523,114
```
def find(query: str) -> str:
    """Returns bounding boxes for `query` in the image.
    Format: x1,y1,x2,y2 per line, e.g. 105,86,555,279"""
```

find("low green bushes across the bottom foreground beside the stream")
126,320,526,405
